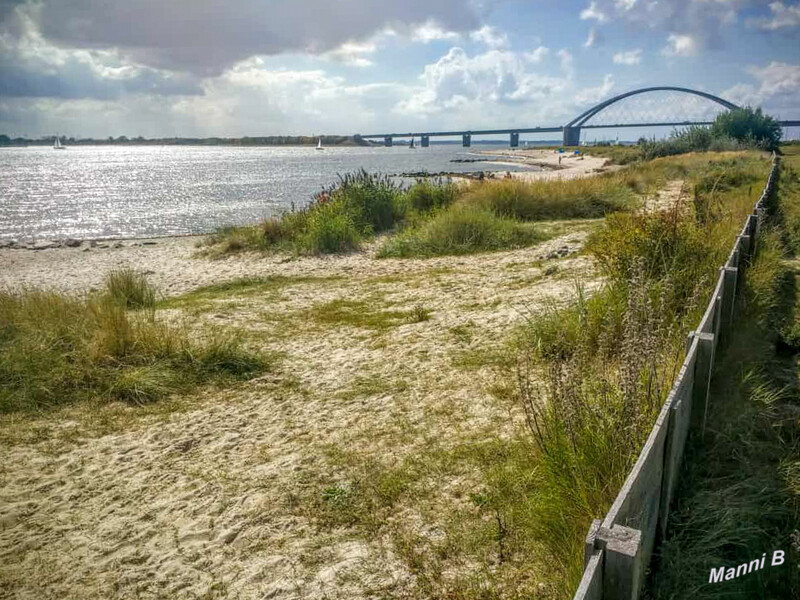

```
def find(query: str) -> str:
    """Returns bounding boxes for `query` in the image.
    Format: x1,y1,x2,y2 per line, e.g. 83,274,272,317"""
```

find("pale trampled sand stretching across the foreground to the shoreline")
0,233,597,600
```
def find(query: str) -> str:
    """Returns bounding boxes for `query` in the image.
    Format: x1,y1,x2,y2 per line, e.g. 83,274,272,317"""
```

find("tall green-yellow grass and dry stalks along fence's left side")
500,154,769,598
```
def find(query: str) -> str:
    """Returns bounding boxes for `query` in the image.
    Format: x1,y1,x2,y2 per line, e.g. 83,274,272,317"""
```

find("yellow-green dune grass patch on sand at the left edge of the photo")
0,270,268,413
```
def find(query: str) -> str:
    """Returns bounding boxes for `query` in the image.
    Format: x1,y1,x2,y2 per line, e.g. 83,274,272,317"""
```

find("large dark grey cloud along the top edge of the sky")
9,0,479,76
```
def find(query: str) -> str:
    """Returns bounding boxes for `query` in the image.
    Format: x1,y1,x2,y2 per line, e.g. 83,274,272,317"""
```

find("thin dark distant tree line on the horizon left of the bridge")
0,134,373,146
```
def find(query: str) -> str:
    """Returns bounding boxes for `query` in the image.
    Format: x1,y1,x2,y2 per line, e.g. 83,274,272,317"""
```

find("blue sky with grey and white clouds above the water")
0,0,800,139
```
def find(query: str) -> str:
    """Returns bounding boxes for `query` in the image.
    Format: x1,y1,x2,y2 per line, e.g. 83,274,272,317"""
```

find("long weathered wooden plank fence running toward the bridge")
574,154,779,600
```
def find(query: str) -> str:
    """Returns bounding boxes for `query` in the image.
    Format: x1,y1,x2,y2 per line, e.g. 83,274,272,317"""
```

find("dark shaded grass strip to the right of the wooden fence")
647,166,800,600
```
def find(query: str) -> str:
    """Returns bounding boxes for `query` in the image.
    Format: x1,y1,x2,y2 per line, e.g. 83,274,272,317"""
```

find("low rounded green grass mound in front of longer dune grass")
378,206,542,257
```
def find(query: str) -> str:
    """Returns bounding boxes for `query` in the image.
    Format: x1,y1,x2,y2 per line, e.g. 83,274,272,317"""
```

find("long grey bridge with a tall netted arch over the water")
355,86,800,148
